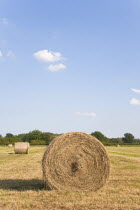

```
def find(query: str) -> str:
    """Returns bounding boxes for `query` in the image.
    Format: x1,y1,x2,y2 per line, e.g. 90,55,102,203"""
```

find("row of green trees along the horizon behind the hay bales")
0,130,140,145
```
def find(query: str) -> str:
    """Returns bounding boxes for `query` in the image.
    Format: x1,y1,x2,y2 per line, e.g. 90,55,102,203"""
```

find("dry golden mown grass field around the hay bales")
0,146,140,210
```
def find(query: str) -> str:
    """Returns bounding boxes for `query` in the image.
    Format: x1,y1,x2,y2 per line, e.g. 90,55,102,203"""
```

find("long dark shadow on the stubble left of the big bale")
0,179,44,191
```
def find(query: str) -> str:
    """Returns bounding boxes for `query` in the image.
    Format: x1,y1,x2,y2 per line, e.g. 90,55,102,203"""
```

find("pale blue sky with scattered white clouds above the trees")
0,0,140,138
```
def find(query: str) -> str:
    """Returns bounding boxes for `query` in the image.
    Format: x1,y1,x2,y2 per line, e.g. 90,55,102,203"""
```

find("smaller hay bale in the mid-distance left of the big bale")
15,142,30,154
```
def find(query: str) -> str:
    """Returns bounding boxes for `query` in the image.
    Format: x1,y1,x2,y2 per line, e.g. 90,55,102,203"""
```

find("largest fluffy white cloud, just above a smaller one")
33,50,63,63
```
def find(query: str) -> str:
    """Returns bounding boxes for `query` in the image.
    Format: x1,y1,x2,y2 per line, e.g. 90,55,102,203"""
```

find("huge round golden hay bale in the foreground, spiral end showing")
42,132,110,191
